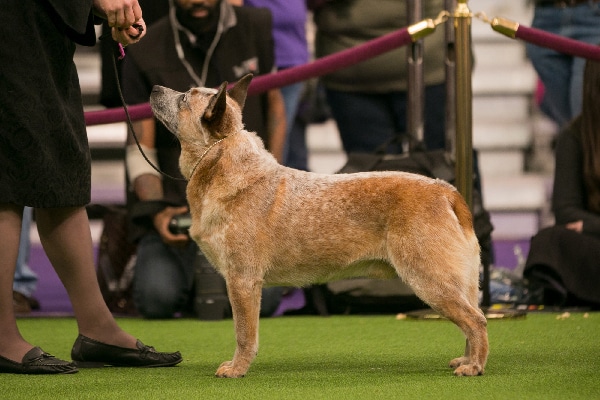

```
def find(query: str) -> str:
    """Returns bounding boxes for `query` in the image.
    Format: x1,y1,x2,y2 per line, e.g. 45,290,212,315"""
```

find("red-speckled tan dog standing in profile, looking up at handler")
150,74,488,377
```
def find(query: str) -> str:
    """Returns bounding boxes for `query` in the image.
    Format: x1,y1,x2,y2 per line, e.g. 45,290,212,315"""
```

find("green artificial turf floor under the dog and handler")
0,313,600,400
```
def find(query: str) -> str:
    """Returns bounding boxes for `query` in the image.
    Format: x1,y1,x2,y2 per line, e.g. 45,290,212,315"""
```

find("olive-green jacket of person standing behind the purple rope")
314,0,446,93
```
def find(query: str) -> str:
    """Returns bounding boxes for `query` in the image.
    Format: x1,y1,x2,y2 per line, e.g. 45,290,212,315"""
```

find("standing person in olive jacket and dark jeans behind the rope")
310,0,446,153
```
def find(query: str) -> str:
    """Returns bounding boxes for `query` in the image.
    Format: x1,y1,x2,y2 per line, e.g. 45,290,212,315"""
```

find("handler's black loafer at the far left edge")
0,347,78,375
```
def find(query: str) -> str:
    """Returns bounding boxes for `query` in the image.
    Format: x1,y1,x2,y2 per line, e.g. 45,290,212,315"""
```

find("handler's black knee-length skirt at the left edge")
0,0,91,208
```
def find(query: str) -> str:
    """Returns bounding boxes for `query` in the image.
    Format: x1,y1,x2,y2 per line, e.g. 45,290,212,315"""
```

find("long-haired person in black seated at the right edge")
524,53,600,309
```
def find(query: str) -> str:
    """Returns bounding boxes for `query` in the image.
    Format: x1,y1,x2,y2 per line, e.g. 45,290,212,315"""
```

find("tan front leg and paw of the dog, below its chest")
215,274,262,378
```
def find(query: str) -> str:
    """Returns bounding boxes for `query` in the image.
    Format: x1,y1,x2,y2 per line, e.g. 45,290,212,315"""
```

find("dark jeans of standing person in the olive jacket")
326,84,446,153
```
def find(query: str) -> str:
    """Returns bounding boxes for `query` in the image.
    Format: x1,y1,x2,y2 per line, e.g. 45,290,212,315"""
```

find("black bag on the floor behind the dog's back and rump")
326,144,493,312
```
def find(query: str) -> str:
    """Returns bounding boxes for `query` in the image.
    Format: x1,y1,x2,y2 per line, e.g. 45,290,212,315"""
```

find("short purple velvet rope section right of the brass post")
515,25,600,61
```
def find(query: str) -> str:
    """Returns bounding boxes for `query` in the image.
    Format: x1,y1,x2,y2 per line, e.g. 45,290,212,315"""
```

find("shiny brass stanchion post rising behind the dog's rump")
454,0,473,210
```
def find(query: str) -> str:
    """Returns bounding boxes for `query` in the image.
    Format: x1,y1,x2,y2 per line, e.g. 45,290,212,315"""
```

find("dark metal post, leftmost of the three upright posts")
406,0,425,144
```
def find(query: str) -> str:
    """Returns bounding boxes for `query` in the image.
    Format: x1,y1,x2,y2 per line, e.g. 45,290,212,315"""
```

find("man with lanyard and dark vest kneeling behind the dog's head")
121,0,286,318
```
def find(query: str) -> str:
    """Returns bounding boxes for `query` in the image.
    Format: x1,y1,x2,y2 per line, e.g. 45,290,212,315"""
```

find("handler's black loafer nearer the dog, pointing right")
71,335,182,368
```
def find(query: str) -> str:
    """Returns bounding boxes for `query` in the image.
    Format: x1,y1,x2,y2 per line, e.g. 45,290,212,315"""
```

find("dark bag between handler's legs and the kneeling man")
96,207,138,315
